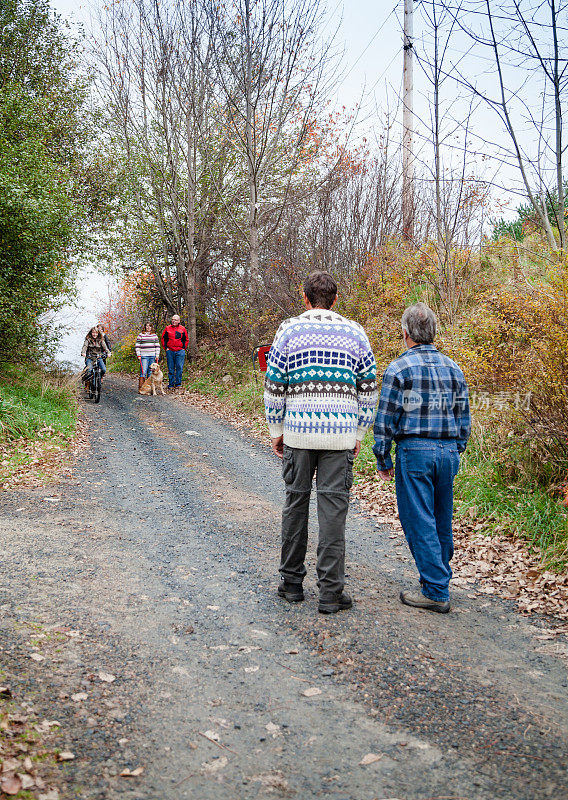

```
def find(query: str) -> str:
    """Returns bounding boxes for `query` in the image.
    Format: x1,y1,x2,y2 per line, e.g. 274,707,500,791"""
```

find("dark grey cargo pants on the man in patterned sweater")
280,445,354,599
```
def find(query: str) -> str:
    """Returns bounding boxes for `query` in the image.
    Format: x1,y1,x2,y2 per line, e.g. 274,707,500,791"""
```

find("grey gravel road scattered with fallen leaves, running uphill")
0,377,568,800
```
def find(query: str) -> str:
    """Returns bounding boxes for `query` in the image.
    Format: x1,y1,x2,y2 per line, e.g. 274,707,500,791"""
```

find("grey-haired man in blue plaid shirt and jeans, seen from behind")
373,303,471,614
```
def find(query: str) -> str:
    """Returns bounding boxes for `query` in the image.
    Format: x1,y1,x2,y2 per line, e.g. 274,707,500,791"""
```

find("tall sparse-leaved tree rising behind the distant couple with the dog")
96,0,226,355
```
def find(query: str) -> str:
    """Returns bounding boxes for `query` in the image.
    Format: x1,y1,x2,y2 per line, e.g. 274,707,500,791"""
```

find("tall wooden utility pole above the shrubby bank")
402,0,414,241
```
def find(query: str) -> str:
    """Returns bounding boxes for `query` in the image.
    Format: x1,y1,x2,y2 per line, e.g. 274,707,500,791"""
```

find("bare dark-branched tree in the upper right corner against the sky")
441,0,568,250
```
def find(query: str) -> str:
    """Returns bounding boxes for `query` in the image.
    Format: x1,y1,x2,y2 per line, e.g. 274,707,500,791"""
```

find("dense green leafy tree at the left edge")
0,0,85,357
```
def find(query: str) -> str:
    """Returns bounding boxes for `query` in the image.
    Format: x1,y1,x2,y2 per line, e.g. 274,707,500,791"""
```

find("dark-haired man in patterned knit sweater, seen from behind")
264,272,378,614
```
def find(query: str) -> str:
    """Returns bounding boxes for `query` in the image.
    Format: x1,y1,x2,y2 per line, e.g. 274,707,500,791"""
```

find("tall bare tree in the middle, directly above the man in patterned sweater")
207,0,338,276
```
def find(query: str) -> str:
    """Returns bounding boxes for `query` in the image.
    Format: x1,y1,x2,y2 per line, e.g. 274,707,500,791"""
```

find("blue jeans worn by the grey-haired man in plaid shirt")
395,436,460,601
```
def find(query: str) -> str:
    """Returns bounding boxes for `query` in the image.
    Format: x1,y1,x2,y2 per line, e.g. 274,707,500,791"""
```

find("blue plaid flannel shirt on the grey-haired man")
373,344,471,471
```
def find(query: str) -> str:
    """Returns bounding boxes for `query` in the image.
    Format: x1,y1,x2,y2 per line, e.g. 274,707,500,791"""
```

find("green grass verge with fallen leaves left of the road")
0,365,78,487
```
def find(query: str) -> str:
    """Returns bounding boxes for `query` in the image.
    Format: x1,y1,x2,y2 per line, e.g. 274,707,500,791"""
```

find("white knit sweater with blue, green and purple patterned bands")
264,308,378,450
